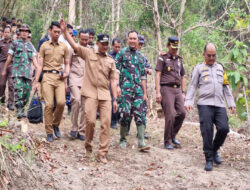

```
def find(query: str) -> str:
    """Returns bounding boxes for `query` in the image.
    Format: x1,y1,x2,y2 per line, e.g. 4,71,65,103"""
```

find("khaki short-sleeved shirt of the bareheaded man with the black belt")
40,40,69,71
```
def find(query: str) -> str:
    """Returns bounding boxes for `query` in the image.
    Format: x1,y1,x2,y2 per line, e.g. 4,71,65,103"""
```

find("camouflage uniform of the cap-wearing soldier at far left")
8,39,35,110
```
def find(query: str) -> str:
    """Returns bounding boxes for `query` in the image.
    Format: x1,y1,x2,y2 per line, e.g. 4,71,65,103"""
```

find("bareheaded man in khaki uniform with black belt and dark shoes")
40,22,69,142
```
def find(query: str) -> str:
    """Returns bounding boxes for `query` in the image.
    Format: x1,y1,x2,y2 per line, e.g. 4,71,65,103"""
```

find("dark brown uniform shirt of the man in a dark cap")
155,53,185,85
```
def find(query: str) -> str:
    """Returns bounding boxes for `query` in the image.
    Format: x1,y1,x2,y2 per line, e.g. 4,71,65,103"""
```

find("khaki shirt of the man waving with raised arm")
76,45,117,101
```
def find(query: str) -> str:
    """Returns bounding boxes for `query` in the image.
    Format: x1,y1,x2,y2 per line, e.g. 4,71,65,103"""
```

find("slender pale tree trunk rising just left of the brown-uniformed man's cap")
153,0,162,52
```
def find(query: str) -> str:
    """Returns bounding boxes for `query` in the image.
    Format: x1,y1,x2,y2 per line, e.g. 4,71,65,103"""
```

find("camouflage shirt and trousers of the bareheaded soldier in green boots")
116,47,146,127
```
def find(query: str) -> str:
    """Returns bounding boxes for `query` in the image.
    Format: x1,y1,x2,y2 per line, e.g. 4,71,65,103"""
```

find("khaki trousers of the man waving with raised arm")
84,97,111,156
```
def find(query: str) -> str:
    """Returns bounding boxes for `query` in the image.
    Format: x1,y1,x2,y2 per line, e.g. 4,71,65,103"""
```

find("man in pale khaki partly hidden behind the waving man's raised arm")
69,30,89,140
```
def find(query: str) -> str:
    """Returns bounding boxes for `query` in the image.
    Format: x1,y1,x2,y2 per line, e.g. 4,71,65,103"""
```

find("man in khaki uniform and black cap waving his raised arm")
60,20,117,163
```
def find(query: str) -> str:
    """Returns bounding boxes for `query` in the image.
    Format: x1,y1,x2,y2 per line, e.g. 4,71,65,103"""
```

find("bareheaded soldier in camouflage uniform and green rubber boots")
116,31,150,151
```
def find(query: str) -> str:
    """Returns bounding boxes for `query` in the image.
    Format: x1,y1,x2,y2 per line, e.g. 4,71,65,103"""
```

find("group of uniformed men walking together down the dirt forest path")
0,16,235,171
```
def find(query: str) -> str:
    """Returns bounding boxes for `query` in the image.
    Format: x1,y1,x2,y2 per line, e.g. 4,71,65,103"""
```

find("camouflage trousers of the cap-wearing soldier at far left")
13,77,32,109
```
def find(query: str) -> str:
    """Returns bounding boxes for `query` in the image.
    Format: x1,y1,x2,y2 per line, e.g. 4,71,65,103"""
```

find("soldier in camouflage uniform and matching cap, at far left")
2,24,40,118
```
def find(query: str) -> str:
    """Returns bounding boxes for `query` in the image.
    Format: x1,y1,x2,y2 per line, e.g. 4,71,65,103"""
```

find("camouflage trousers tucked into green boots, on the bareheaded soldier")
118,91,146,127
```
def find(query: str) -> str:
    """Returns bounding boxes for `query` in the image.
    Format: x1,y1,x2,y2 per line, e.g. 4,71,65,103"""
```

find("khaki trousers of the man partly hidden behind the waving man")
69,86,85,135
